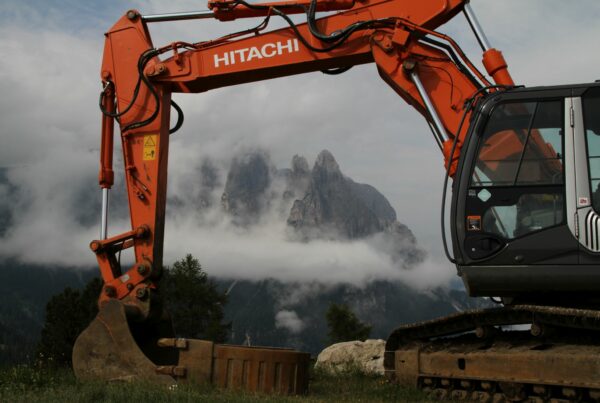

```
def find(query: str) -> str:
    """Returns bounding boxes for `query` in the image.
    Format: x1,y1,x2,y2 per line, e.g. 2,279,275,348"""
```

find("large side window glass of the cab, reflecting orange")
468,100,564,239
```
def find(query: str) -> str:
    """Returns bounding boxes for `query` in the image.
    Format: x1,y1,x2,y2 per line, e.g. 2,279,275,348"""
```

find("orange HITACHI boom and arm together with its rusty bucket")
73,0,513,393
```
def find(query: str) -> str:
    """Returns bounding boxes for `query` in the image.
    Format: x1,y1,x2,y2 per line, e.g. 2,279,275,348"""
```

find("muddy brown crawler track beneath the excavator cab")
384,305,600,402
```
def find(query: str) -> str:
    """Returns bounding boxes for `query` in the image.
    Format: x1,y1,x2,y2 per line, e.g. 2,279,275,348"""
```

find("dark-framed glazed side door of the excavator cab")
456,91,579,267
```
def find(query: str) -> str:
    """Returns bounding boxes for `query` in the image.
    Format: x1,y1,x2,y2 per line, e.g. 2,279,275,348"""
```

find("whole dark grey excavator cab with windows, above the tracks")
452,84,600,303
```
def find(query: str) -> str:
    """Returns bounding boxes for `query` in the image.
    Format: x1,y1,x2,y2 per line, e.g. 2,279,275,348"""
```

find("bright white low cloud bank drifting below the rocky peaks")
159,159,455,288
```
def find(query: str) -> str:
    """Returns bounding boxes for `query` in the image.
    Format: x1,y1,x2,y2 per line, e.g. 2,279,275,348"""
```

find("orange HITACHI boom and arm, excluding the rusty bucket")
91,0,512,314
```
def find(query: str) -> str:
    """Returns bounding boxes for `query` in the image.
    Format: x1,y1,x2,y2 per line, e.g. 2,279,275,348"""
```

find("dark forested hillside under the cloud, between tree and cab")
219,280,487,354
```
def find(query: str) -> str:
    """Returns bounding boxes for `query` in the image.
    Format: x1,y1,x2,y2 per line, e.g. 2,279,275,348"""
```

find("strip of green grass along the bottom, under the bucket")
0,367,429,403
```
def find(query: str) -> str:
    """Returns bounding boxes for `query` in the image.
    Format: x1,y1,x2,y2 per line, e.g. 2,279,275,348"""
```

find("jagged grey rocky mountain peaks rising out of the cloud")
221,150,425,267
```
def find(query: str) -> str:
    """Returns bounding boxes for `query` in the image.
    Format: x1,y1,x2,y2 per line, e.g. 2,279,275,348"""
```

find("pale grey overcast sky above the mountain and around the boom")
0,0,600,283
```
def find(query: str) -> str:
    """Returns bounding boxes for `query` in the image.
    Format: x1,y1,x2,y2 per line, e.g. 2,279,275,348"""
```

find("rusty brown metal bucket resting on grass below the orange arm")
73,300,310,394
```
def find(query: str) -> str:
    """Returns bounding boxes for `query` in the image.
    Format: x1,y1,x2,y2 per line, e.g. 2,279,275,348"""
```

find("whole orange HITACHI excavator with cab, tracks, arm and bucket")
73,0,600,402
